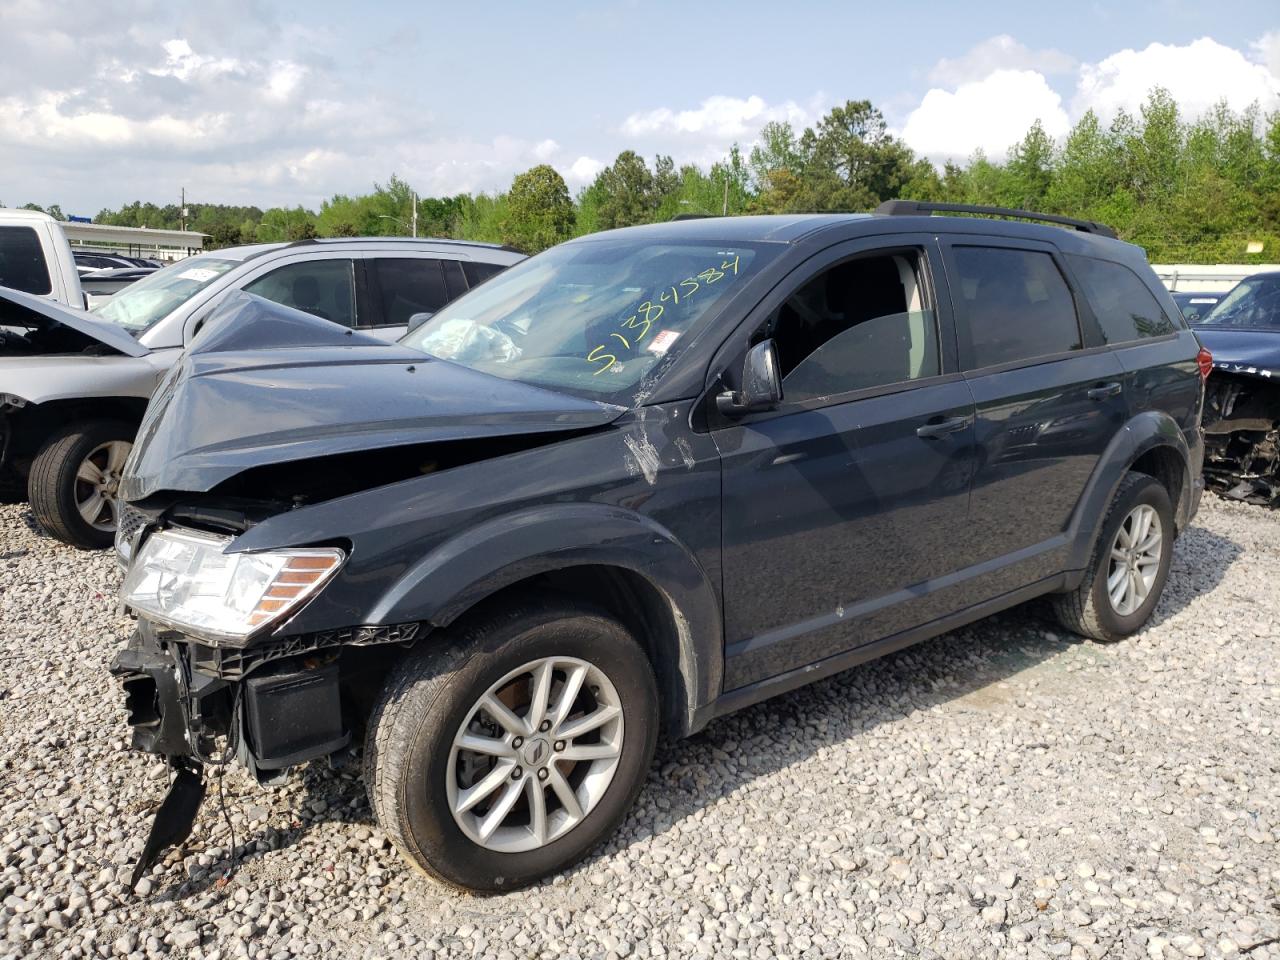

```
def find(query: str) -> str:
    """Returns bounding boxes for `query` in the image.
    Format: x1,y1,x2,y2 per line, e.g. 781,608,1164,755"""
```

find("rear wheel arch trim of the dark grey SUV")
1068,410,1194,571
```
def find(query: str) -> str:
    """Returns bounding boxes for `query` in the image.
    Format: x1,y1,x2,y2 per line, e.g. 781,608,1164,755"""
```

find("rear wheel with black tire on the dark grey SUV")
1051,472,1175,643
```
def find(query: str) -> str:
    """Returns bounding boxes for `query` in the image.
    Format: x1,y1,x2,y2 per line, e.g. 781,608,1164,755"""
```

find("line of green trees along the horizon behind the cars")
17,88,1280,262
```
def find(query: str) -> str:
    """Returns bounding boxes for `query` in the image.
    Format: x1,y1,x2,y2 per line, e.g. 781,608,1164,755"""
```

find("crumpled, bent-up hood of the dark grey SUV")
120,294,625,500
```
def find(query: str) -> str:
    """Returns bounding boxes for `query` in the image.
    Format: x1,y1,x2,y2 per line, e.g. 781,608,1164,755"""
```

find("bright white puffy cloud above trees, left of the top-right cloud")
901,70,1071,160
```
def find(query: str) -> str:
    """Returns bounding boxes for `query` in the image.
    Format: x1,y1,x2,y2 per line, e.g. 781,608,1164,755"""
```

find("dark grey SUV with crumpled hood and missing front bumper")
113,202,1208,890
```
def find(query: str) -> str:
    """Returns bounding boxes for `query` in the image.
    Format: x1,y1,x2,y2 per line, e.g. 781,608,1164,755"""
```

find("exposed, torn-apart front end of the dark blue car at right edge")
1203,364,1280,507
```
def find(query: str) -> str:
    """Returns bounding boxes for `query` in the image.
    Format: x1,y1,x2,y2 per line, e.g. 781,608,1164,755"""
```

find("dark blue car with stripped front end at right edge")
1196,271,1280,507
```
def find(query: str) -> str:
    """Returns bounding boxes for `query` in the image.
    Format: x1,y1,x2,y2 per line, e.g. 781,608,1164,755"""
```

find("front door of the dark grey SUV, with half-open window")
712,237,973,690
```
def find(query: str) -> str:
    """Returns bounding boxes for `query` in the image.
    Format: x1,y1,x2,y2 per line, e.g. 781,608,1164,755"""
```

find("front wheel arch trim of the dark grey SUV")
370,503,723,717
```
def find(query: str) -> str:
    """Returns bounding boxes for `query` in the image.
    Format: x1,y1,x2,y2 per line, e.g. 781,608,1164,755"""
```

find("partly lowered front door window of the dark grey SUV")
768,251,938,402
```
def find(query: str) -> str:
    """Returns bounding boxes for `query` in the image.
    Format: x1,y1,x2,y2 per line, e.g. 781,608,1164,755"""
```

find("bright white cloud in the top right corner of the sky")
1071,35,1280,119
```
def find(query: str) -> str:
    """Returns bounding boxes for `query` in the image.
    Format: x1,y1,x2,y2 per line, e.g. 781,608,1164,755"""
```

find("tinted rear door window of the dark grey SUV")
951,247,1082,370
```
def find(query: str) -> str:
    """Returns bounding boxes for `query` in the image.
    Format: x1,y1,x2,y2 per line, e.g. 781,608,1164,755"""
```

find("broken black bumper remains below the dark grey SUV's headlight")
111,620,351,780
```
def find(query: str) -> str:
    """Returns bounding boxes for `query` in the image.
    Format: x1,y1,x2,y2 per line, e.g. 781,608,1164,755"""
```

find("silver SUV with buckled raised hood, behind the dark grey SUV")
0,239,522,548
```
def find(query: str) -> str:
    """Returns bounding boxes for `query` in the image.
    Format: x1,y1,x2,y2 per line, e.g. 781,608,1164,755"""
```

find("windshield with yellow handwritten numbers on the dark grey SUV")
401,238,776,402
